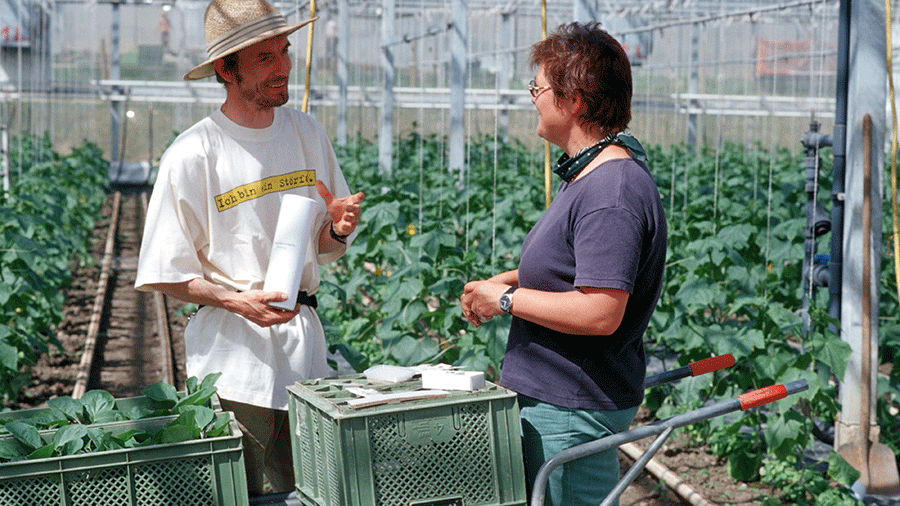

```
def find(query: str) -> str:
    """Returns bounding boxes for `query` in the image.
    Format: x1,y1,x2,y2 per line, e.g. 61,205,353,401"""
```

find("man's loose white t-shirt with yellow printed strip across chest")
135,107,353,409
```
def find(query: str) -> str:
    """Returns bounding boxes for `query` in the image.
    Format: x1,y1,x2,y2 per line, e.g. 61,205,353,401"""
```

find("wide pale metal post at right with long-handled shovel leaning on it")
832,0,889,447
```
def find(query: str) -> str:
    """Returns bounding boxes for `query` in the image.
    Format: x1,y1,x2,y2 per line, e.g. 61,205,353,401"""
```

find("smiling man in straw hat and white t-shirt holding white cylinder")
135,0,363,495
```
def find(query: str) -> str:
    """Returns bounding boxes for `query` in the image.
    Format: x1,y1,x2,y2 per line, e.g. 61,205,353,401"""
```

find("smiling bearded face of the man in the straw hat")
234,35,291,109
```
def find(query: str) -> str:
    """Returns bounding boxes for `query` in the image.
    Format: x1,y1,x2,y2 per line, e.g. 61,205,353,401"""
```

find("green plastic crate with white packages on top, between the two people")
288,375,526,506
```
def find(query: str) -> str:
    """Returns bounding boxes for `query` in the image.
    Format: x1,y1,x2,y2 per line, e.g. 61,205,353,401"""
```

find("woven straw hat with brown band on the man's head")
184,0,318,81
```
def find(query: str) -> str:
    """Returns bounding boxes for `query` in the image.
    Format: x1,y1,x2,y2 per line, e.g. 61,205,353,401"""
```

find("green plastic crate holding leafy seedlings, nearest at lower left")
0,413,249,506
